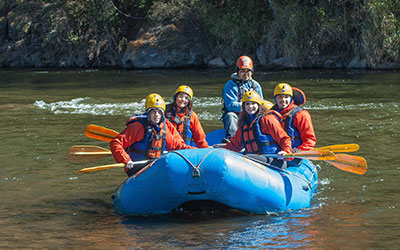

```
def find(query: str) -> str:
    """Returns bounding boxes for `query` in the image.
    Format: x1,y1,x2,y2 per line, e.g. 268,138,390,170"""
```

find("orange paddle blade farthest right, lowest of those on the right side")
327,154,368,175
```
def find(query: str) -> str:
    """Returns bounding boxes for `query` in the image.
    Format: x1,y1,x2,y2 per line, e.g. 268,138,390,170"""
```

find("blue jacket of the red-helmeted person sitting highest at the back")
222,73,264,113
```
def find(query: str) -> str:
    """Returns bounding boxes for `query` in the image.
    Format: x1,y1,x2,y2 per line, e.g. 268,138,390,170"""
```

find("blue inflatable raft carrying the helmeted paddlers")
114,148,318,215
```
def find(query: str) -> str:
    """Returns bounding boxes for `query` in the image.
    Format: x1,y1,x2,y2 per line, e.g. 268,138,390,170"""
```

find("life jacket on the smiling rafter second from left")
165,107,193,145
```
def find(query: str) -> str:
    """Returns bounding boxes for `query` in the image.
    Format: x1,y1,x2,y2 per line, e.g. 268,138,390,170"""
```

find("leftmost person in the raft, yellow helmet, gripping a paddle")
110,94,194,176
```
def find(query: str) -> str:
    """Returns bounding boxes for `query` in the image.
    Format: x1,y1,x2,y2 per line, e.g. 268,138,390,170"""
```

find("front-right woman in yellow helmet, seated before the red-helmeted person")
223,91,292,167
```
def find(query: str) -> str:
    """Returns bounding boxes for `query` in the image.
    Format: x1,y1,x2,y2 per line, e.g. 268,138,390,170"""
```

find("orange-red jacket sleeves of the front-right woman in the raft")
223,115,292,154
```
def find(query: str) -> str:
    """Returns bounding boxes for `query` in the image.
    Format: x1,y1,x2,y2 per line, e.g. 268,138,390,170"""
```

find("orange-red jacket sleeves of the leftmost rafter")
110,120,195,163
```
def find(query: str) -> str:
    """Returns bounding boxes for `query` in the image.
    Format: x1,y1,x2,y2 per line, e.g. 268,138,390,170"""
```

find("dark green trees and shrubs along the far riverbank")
0,0,400,68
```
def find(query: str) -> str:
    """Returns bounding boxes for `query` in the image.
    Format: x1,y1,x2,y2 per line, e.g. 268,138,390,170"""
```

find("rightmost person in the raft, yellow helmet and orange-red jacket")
271,83,317,153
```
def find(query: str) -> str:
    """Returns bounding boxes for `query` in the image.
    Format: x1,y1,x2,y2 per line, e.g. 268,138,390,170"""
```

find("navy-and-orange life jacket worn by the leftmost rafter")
125,114,167,161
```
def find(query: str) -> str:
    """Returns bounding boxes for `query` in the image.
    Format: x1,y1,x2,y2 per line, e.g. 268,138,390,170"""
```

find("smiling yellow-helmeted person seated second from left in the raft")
165,85,209,148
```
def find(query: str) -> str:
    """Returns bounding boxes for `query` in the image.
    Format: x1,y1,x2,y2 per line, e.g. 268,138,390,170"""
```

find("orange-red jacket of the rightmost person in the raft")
280,101,317,151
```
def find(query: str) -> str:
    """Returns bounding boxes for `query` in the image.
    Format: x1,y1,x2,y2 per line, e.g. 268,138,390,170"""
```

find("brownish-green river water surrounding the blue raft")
0,69,400,249
